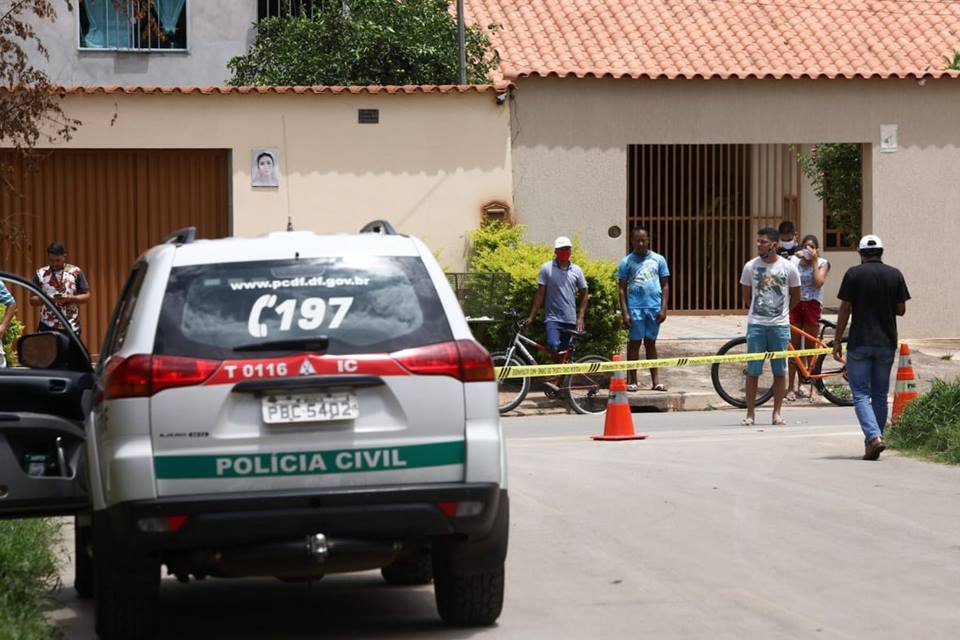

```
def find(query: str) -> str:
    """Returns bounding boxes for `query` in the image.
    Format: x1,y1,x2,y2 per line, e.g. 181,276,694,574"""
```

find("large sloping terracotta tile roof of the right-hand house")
465,0,960,79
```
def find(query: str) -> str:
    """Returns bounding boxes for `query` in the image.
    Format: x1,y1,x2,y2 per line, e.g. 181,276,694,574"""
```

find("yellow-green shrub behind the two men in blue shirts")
469,221,626,359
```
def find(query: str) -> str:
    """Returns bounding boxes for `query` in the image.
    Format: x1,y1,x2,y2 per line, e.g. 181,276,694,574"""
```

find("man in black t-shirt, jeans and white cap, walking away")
833,235,910,460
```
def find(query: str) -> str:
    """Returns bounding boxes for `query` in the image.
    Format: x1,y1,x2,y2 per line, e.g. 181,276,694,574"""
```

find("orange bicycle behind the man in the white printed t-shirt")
710,319,853,409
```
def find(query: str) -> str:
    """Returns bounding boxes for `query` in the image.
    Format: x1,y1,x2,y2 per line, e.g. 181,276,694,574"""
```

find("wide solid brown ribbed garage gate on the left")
0,149,230,353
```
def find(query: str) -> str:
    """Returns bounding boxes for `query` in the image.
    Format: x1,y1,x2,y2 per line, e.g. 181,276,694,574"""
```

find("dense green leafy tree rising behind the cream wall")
227,0,498,86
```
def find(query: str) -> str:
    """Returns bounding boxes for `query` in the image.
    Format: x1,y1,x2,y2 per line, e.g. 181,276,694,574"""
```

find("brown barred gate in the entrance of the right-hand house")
627,144,800,313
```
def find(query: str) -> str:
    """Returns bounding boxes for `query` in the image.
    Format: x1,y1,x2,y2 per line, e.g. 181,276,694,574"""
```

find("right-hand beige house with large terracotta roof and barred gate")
466,0,960,337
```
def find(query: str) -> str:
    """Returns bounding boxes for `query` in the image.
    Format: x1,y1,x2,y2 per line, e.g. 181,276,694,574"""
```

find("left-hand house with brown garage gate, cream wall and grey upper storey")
0,0,511,353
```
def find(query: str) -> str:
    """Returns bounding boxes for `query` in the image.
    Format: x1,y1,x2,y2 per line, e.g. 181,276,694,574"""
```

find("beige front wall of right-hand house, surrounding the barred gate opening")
511,78,960,337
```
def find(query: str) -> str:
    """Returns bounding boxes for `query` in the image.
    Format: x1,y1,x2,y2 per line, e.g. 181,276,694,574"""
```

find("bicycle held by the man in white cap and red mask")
490,309,612,414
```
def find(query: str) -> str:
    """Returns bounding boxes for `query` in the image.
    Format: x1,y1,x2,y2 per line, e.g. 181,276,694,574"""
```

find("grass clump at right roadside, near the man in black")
885,379,960,464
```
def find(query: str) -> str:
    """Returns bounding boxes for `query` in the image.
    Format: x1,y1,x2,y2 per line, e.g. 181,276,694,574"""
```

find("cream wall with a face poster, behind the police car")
47,91,511,270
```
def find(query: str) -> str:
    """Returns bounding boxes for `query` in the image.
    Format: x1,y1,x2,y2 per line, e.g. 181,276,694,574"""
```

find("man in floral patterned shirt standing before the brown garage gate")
30,242,90,336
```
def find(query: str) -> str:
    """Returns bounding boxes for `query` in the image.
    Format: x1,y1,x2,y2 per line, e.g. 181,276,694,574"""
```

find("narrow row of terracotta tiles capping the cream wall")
57,81,510,95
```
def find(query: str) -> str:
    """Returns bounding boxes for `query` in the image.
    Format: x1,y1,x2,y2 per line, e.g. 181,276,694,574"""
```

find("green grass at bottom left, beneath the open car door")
0,518,60,640
